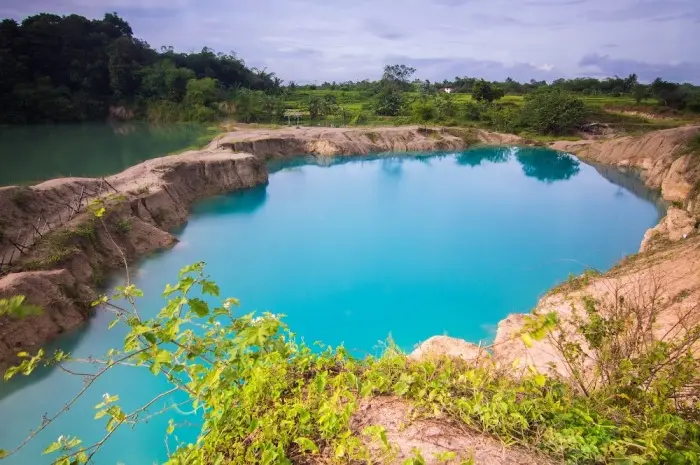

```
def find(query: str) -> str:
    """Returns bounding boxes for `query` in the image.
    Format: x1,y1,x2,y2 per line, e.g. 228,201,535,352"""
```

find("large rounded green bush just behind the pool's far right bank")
522,88,588,135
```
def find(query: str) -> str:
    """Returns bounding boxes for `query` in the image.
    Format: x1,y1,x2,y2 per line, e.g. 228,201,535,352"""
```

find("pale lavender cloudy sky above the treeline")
0,0,700,84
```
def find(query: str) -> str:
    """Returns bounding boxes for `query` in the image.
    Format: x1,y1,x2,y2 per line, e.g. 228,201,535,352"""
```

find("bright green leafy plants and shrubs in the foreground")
0,260,700,465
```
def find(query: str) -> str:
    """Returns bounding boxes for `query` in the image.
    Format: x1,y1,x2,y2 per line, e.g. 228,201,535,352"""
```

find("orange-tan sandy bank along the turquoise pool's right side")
493,126,700,376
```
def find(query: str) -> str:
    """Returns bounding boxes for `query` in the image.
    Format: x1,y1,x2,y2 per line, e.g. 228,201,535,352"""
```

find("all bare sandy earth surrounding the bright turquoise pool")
0,126,700,464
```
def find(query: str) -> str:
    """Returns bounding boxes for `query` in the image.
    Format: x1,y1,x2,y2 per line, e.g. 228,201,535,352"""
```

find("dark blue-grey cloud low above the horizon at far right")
579,54,700,82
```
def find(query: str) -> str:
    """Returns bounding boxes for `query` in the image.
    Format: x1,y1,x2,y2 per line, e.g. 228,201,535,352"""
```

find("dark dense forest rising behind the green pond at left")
0,13,281,124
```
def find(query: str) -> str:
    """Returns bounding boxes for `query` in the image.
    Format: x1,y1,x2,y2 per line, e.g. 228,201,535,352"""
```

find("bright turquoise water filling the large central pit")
0,148,660,464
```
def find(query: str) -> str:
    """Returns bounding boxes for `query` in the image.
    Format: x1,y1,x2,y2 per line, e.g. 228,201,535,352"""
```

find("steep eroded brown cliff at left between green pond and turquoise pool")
0,151,267,367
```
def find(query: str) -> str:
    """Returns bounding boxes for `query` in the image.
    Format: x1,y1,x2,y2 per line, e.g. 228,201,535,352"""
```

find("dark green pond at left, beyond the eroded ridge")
0,122,206,186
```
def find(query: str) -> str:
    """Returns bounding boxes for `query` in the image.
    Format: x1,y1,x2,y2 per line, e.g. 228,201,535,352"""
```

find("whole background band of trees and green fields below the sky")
0,13,700,137
